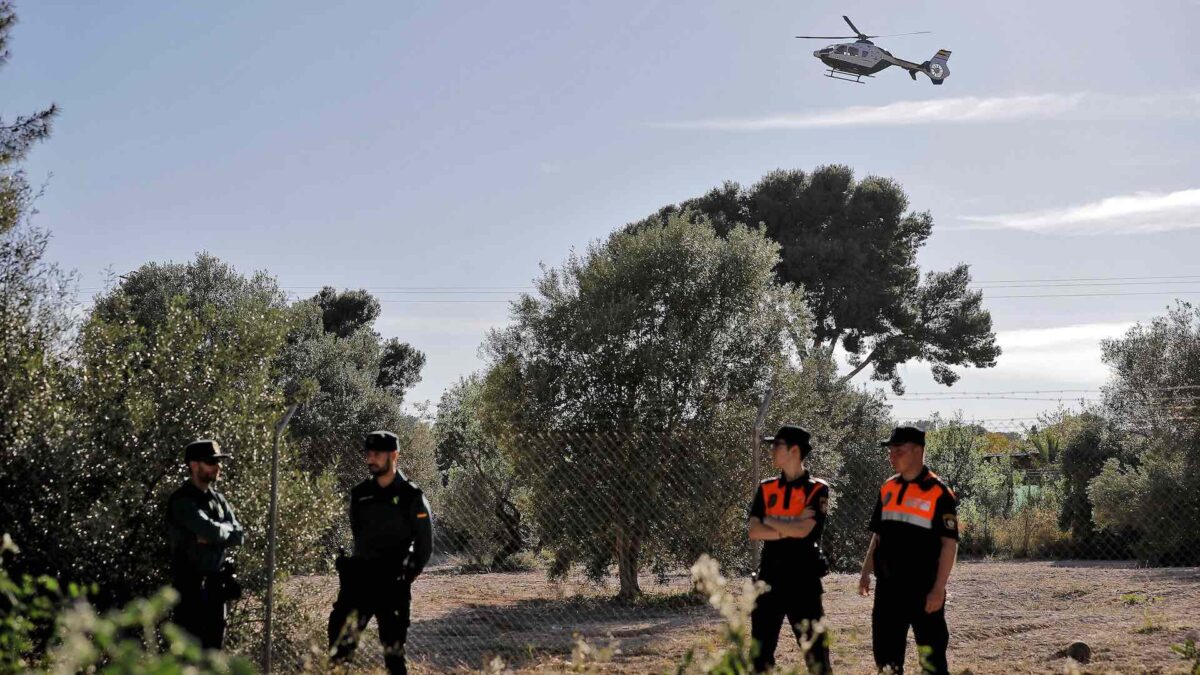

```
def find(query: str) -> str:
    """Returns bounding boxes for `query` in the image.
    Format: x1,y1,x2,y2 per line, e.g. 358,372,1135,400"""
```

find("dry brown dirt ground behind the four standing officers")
289,561,1200,674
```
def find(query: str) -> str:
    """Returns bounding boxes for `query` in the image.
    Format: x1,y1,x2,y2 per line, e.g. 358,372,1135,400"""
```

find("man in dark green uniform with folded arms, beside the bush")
167,438,245,650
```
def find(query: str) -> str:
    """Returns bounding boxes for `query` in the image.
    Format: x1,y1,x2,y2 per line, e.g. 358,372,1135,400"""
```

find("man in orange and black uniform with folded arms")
749,425,833,673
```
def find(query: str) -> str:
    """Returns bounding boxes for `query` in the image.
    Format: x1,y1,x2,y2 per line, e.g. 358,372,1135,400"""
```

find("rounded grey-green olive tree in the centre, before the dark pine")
488,217,804,597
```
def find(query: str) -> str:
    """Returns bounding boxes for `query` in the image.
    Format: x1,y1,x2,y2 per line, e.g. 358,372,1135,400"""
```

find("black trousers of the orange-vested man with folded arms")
750,571,833,674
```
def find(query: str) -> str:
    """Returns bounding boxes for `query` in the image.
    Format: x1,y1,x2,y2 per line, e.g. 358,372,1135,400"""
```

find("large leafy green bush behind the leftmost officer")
0,252,342,611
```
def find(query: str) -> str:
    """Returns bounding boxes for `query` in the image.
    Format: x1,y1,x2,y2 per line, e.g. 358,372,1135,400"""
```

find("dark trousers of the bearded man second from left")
329,577,413,675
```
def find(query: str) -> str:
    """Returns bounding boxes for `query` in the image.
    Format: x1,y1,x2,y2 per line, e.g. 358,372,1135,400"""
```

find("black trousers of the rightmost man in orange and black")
871,581,950,675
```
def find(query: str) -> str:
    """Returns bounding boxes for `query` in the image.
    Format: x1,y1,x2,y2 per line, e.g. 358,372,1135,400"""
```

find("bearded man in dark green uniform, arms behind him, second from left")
329,431,433,675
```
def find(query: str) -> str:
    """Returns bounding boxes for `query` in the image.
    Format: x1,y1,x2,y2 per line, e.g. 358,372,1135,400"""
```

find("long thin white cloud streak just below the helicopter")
649,92,1200,132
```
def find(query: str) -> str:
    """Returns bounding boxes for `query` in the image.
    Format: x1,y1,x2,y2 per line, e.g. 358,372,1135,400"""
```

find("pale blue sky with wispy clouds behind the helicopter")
9,0,1200,418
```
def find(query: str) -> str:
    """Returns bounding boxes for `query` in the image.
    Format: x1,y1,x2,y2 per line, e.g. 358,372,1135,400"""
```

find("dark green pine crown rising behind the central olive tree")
628,165,1000,393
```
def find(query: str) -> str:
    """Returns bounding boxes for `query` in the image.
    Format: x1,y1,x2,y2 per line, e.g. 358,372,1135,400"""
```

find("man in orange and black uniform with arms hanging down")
858,426,959,674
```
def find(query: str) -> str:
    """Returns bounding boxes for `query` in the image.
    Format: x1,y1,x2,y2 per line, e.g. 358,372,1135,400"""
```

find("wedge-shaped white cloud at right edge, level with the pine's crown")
964,190,1200,234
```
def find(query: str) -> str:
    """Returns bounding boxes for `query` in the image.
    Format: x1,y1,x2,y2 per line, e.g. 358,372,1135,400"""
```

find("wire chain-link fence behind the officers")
243,414,1200,673
